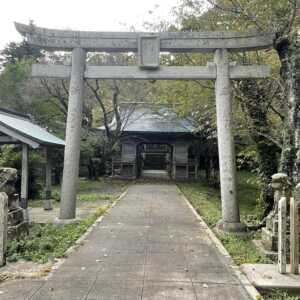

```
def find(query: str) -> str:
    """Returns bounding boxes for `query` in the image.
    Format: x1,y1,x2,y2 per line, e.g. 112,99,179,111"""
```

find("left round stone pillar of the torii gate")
59,48,86,222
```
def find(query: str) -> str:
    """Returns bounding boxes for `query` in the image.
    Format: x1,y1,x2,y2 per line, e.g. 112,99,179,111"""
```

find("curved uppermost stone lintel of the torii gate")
15,23,274,52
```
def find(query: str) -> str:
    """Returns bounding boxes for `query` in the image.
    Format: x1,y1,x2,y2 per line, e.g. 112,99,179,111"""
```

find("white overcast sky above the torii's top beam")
0,0,178,49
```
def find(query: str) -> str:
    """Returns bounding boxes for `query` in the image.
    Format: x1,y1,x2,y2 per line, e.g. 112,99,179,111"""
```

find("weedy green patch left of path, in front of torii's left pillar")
7,206,108,263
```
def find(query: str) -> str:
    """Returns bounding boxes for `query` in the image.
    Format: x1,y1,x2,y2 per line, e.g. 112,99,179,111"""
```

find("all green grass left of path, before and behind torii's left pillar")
21,178,128,263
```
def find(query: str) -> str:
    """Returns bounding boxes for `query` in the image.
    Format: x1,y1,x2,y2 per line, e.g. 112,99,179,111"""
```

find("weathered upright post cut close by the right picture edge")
290,183,300,274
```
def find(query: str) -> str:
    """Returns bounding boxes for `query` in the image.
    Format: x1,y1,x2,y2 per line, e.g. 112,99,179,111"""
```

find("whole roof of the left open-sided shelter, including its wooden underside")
0,108,65,148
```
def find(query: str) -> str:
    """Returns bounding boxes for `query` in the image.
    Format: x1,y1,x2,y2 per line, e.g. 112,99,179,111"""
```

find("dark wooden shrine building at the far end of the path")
108,103,198,179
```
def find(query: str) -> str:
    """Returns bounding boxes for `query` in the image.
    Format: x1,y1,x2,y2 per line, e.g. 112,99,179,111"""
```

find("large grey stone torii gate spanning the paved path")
15,23,273,232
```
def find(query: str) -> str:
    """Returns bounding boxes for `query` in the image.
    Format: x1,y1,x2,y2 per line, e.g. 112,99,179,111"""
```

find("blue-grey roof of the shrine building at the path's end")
101,103,196,133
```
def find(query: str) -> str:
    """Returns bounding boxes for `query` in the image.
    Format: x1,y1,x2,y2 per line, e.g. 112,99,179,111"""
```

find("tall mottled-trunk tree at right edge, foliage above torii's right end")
200,0,300,183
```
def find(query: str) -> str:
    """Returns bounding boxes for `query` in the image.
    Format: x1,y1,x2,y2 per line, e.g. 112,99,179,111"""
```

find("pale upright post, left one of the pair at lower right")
278,197,287,274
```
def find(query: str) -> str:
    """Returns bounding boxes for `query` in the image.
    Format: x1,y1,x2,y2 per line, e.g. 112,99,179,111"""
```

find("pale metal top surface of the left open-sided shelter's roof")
0,109,65,146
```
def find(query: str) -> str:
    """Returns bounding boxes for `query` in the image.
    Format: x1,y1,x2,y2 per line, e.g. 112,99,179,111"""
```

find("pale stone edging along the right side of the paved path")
176,185,263,300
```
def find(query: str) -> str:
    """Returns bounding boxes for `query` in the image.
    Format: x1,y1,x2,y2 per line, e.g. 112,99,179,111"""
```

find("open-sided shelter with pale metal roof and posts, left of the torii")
0,108,65,216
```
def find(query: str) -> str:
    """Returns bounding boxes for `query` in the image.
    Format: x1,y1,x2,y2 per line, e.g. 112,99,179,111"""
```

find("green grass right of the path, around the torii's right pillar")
178,172,267,265
